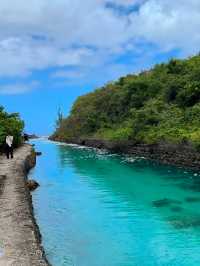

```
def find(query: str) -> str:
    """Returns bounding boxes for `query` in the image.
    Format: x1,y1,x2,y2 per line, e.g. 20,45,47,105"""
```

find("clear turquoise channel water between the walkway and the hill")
30,140,200,266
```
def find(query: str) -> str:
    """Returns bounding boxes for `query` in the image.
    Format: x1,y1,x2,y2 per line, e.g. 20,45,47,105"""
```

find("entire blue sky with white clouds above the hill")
0,0,200,135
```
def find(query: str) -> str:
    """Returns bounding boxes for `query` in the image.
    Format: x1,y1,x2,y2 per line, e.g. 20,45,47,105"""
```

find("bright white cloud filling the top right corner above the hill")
131,0,200,55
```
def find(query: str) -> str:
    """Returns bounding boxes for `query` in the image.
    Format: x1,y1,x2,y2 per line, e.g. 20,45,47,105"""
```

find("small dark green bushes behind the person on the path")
0,106,24,151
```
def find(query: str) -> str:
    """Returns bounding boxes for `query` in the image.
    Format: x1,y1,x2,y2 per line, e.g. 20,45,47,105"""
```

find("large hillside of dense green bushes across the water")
53,55,200,148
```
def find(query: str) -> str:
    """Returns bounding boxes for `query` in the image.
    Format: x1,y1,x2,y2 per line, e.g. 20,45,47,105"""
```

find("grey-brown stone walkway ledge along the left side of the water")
0,144,49,266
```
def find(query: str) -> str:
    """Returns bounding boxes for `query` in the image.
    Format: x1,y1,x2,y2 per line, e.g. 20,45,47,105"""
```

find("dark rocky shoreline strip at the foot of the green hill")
50,138,200,170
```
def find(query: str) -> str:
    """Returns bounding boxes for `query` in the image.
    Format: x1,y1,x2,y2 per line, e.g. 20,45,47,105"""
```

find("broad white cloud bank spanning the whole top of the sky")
0,0,200,93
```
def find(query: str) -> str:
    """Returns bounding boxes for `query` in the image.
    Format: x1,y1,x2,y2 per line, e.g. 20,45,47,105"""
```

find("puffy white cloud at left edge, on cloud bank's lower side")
0,37,91,76
